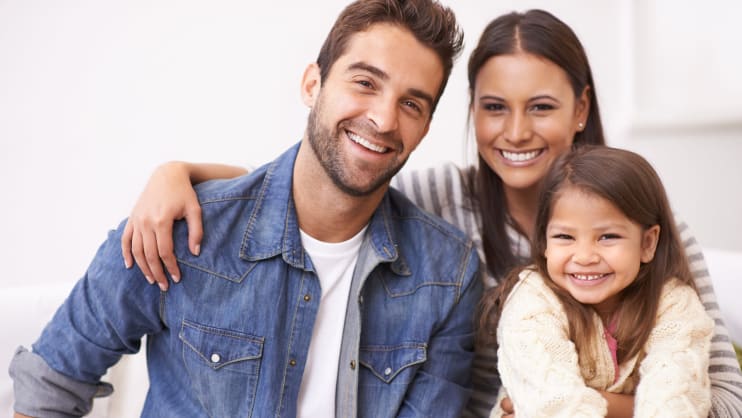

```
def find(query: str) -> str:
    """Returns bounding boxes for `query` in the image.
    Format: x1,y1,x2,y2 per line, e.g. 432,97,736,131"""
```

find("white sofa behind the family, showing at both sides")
0,249,742,418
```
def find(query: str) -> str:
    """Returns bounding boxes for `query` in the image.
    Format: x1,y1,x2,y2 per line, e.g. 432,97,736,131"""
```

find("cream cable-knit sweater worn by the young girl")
491,269,714,418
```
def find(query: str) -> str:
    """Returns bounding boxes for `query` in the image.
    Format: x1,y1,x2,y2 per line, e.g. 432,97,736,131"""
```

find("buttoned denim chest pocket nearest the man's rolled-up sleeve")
178,320,264,417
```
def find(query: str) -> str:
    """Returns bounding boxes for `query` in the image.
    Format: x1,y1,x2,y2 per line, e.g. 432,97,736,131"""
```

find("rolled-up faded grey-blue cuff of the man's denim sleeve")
8,347,113,418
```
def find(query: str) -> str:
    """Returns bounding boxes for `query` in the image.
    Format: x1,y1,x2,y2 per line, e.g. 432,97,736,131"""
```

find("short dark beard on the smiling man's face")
307,96,407,197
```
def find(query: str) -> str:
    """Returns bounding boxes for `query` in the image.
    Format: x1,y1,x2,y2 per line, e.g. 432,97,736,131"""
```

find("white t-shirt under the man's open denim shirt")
297,227,366,418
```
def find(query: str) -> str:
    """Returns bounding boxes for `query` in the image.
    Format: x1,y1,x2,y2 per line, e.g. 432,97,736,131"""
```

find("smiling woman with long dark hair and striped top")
122,10,742,417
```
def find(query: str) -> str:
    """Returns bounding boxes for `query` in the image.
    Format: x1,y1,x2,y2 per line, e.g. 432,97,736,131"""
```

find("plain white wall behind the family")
0,0,742,285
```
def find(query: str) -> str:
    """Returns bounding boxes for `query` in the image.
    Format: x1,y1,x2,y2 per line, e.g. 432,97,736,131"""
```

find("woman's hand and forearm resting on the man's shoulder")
121,161,247,290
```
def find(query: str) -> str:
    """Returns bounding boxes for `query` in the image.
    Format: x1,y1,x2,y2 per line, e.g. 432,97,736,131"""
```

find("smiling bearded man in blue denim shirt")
11,0,481,417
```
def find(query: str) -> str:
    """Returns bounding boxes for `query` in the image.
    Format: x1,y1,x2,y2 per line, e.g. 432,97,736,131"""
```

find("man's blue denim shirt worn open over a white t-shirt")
11,145,481,418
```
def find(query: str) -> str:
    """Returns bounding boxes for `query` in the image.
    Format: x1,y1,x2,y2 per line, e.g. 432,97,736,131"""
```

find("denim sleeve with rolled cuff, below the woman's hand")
10,224,163,417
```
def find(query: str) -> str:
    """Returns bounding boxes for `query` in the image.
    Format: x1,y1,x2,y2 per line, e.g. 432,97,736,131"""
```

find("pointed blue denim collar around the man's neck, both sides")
240,141,410,276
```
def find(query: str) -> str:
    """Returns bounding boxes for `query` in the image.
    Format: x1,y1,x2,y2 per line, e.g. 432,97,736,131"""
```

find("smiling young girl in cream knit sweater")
481,146,714,417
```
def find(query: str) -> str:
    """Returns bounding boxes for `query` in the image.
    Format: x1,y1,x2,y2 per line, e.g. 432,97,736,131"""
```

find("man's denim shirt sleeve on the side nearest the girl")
397,250,482,418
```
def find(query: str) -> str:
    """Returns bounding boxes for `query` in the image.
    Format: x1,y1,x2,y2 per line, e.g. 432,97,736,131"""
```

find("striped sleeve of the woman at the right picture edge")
675,216,742,418
